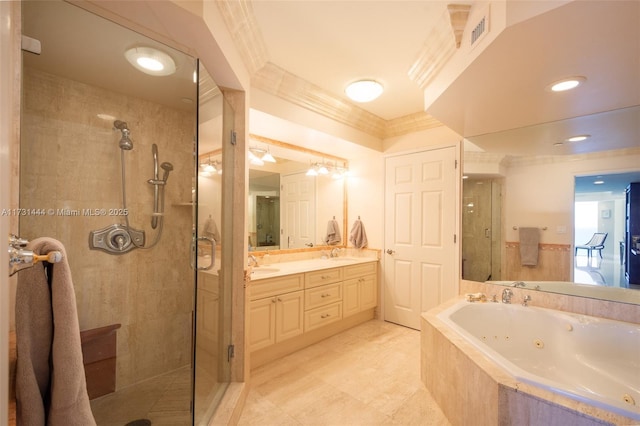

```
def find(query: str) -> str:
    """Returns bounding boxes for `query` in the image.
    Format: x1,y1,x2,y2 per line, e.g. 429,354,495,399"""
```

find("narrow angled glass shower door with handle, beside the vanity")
193,65,234,425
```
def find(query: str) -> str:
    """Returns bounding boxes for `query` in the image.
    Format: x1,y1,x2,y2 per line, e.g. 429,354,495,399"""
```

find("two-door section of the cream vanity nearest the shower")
249,274,304,351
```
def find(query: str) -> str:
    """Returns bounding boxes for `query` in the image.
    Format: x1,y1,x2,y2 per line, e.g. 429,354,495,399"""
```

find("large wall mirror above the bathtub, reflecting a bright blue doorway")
462,106,640,304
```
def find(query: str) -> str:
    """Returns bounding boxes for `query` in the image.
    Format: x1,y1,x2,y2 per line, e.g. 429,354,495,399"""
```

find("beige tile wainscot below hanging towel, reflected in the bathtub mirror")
504,242,573,281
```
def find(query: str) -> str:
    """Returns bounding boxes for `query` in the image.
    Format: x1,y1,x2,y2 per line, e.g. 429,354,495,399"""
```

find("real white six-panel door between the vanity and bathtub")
384,147,459,329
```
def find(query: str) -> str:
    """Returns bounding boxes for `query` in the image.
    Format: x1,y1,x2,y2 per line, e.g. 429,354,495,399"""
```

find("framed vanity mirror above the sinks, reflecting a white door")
248,135,349,252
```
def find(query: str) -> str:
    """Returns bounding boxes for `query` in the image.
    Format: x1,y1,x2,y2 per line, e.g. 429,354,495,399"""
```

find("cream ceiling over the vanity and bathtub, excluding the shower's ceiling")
228,0,640,155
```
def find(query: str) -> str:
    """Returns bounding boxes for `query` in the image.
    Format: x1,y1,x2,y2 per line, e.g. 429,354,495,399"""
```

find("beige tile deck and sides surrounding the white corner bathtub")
421,290,637,426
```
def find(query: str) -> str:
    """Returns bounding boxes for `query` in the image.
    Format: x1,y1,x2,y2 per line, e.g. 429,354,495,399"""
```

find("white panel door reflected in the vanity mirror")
280,173,316,248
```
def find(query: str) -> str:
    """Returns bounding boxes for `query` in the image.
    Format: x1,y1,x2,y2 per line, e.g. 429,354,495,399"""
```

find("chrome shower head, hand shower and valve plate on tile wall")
89,120,173,254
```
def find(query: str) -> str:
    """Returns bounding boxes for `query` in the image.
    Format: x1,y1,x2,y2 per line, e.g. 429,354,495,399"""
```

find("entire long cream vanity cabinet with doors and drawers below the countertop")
248,261,378,367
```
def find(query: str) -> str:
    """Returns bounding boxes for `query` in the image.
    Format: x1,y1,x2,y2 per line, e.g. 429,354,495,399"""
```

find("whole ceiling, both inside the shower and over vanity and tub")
23,0,640,155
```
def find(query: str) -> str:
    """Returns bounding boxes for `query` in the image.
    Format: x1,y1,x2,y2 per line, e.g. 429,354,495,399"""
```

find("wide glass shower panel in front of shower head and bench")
19,1,198,425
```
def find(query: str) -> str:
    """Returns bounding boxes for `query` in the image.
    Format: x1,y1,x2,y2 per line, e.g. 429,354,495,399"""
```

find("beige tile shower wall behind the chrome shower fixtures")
20,69,195,388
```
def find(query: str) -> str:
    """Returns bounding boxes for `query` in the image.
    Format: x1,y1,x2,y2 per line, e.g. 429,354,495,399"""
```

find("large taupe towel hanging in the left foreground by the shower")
16,238,96,426
